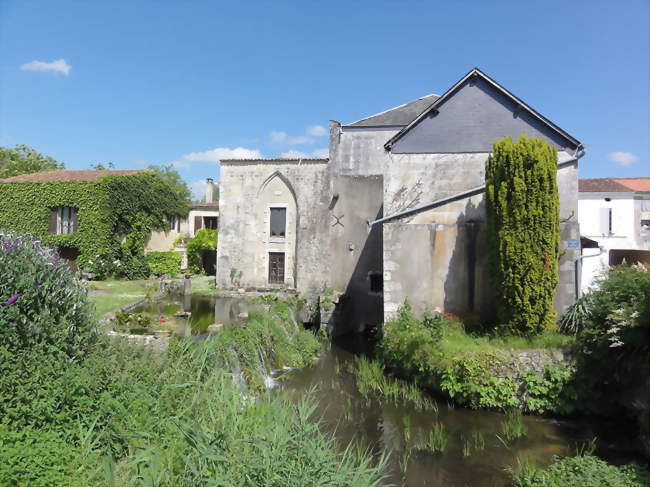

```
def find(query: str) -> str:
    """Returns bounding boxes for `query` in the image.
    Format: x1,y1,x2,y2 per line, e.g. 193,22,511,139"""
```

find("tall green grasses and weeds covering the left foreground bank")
0,303,385,487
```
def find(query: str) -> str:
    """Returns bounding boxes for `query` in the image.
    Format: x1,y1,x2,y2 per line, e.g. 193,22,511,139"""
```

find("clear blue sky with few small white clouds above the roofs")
0,0,650,198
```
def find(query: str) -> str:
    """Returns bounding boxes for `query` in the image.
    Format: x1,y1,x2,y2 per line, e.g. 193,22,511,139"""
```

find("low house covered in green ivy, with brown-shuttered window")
0,170,188,278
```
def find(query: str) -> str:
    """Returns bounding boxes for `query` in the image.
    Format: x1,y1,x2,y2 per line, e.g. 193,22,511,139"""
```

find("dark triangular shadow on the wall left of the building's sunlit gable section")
335,205,384,335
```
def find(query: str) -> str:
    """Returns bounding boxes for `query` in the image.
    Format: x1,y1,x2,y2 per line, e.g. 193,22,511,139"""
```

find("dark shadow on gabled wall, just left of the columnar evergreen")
442,199,494,328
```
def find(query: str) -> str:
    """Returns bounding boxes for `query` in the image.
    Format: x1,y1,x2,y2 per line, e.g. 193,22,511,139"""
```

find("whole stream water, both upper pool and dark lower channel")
137,294,639,487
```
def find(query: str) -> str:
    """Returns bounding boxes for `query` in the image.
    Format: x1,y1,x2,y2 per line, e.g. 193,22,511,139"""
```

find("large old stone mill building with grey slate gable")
217,68,584,332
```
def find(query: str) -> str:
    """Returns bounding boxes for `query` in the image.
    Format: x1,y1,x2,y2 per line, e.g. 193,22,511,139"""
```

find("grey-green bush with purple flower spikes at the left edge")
0,233,95,358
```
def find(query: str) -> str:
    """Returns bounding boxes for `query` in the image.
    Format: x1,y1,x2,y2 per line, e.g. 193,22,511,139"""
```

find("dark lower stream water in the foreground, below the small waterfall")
280,336,635,487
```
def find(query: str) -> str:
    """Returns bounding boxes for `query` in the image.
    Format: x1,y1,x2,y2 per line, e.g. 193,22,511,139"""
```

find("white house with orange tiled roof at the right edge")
578,178,650,291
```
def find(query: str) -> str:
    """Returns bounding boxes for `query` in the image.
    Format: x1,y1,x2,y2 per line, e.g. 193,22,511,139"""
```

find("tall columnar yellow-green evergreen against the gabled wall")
485,136,560,335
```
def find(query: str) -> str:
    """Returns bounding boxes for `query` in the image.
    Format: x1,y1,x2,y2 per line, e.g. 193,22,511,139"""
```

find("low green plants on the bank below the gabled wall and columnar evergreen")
377,303,576,414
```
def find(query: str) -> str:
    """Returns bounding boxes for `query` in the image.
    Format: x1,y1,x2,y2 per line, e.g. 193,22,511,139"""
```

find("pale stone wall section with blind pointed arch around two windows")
217,159,330,296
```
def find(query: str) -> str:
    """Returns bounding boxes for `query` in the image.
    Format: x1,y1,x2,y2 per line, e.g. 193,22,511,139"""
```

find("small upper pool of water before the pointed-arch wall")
134,294,264,336
